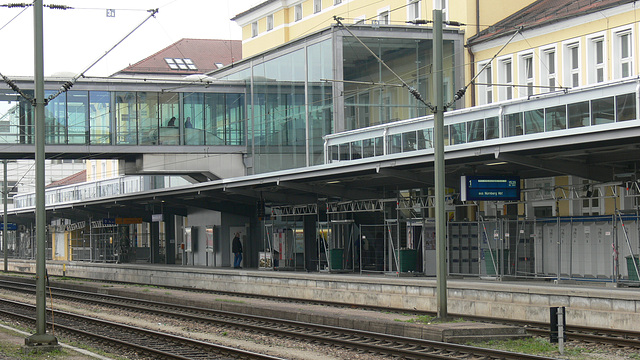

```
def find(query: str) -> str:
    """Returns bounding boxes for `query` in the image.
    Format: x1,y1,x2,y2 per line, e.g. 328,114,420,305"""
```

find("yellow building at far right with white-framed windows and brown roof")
467,0,640,216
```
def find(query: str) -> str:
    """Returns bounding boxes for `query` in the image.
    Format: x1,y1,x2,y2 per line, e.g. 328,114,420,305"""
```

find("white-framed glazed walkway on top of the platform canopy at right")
324,79,640,163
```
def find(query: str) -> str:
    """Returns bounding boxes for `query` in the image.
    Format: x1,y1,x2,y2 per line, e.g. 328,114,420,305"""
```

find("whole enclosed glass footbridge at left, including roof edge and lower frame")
0,78,247,153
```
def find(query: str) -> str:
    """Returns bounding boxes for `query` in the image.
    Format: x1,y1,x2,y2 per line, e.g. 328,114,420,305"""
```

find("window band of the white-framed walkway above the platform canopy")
327,92,638,162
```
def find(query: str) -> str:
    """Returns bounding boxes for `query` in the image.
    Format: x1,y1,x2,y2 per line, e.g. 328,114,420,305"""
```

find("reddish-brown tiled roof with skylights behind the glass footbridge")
118,39,242,75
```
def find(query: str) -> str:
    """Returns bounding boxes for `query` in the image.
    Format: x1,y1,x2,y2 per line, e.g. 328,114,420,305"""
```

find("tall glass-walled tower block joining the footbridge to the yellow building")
213,26,460,173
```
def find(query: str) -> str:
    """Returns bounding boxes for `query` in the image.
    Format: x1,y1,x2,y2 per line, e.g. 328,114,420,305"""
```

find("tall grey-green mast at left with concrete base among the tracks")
24,0,58,349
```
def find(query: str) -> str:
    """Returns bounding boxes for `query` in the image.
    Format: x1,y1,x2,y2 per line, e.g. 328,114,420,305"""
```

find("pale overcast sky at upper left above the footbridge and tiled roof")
0,0,262,76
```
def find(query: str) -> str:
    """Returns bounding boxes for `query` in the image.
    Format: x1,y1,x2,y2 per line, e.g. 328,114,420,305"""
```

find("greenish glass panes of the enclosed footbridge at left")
7,90,247,146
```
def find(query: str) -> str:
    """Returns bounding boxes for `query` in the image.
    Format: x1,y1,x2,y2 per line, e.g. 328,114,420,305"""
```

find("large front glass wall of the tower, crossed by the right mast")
342,36,458,130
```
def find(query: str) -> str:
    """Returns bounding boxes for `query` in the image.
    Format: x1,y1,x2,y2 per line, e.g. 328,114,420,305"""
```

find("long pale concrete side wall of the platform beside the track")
8,260,640,331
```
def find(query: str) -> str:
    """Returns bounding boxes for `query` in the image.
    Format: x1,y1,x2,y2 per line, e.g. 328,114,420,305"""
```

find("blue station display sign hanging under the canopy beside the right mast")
460,176,520,201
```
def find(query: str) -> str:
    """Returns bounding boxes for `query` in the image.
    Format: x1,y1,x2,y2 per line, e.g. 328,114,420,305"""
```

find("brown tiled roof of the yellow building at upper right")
467,0,635,45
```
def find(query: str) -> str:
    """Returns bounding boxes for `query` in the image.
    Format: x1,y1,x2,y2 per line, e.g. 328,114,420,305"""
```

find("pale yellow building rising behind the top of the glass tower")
232,0,534,106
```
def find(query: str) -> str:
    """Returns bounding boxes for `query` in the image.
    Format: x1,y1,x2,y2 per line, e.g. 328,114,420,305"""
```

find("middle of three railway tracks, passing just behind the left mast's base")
0,282,550,360
